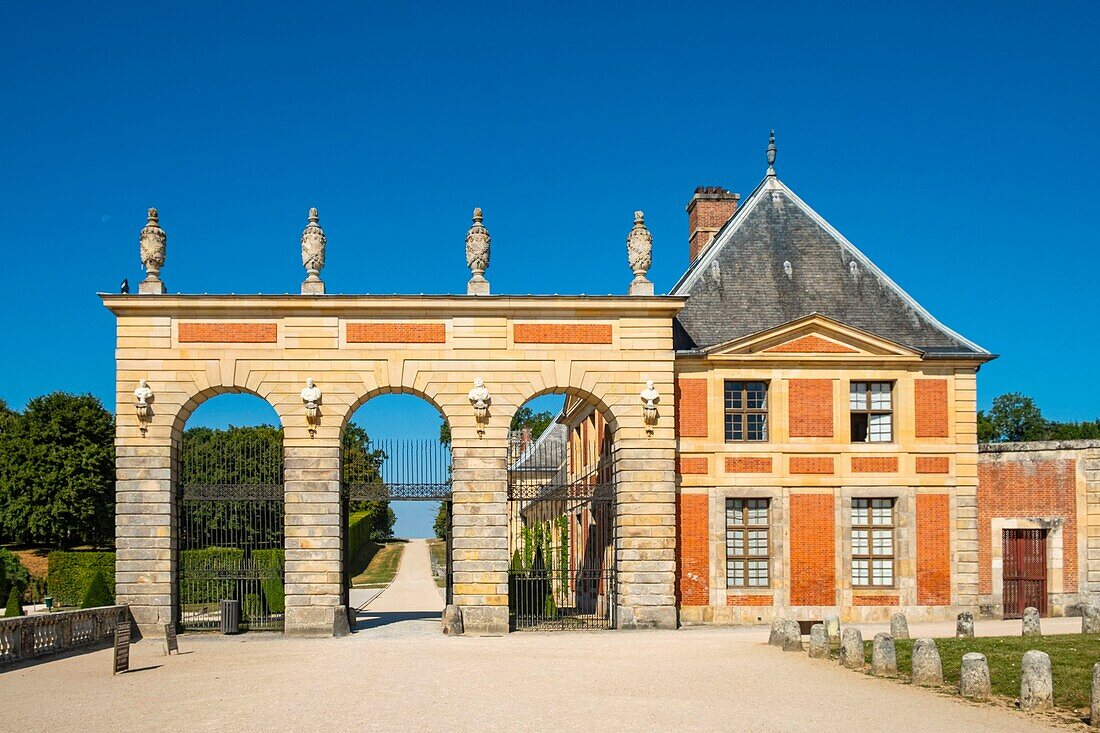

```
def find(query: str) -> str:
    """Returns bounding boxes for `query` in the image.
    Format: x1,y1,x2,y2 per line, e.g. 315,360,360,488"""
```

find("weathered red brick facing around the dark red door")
978,457,1078,593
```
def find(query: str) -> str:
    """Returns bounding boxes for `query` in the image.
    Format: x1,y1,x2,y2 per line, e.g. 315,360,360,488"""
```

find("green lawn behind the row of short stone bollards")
864,634,1100,713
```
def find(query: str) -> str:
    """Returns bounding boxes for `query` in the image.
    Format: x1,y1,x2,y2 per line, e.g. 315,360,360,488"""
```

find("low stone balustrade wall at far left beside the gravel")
0,605,130,668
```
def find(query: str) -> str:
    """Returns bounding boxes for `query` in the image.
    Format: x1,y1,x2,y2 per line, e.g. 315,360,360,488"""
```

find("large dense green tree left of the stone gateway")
0,392,114,547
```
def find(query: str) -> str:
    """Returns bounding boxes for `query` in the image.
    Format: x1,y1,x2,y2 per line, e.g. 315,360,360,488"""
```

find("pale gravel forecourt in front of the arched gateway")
0,620,1065,733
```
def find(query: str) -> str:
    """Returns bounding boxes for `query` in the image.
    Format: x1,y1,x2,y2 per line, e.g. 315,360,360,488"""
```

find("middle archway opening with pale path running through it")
341,393,452,631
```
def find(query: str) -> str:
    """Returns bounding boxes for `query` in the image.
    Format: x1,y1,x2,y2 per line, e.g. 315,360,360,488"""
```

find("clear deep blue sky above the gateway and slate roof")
0,2,1100,537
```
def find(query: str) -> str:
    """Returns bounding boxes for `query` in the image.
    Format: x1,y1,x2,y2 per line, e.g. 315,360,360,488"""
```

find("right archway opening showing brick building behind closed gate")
508,390,616,631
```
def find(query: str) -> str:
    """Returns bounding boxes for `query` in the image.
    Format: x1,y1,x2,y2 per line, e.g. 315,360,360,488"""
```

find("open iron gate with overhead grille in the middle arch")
341,428,452,609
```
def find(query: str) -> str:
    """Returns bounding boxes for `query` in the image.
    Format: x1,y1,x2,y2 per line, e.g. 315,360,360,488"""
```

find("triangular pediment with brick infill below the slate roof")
706,314,922,359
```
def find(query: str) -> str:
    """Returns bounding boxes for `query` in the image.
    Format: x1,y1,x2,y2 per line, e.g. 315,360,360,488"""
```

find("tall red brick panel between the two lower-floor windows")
791,494,836,605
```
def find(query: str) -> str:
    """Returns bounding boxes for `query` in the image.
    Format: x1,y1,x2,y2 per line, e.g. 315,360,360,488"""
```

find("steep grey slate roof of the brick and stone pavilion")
670,175,992,358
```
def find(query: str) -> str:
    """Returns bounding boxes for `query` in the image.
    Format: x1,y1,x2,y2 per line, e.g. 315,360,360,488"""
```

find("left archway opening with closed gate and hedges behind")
174,393,286,633
